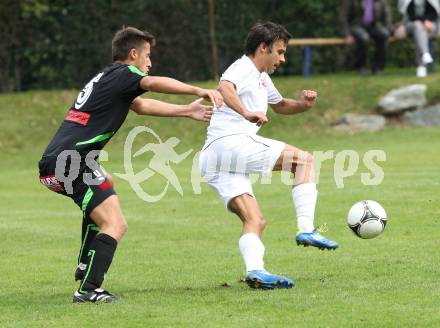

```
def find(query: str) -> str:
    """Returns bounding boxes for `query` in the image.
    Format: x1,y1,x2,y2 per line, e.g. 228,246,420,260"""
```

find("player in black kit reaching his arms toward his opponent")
39,27,222,303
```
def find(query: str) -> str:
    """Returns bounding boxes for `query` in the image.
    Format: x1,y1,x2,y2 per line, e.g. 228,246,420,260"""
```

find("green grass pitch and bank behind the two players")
0,71,440,328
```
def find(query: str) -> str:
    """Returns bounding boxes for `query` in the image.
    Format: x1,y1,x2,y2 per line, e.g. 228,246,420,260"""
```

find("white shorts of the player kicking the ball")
199,134,286,209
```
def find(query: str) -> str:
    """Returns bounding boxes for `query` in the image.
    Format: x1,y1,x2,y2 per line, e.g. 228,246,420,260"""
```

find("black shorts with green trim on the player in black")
38,157,116,216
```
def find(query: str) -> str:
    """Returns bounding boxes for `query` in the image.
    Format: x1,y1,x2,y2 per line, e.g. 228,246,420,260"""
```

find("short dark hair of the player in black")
112,26,155,61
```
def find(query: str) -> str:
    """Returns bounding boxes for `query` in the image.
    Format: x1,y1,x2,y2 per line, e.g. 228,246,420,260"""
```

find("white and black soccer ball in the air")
347,200,387,239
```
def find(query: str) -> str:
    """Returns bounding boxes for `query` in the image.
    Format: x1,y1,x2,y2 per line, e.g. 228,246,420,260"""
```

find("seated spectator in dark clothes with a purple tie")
340,0,391,75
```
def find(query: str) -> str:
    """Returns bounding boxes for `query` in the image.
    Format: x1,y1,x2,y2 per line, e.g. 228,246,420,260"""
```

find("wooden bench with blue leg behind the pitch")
288,34,440,79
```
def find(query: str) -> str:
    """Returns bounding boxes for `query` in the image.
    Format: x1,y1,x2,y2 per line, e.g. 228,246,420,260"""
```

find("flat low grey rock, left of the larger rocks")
334,114,386,132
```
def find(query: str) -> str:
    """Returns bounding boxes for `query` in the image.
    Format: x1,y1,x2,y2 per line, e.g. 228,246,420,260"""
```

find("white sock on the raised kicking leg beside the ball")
292,182,318,232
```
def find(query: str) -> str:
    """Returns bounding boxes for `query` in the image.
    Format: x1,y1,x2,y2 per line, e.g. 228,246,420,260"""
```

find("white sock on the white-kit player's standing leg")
238,233,265,272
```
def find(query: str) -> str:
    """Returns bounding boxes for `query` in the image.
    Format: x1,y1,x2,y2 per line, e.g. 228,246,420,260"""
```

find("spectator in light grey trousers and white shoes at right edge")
399,0,440,77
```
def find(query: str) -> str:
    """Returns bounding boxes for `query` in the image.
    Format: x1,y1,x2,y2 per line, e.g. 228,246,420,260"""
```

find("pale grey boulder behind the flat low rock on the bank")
378,84,427,115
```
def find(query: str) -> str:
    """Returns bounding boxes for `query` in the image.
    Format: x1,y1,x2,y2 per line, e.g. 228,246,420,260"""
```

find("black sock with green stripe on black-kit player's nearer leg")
79,233,118,293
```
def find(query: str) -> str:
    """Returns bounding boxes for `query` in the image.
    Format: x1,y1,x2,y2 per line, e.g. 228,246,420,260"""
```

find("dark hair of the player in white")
245,22,292,55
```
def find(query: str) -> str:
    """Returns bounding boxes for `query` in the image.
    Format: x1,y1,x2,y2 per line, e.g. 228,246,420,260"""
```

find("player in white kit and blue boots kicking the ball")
199,22,338,289
